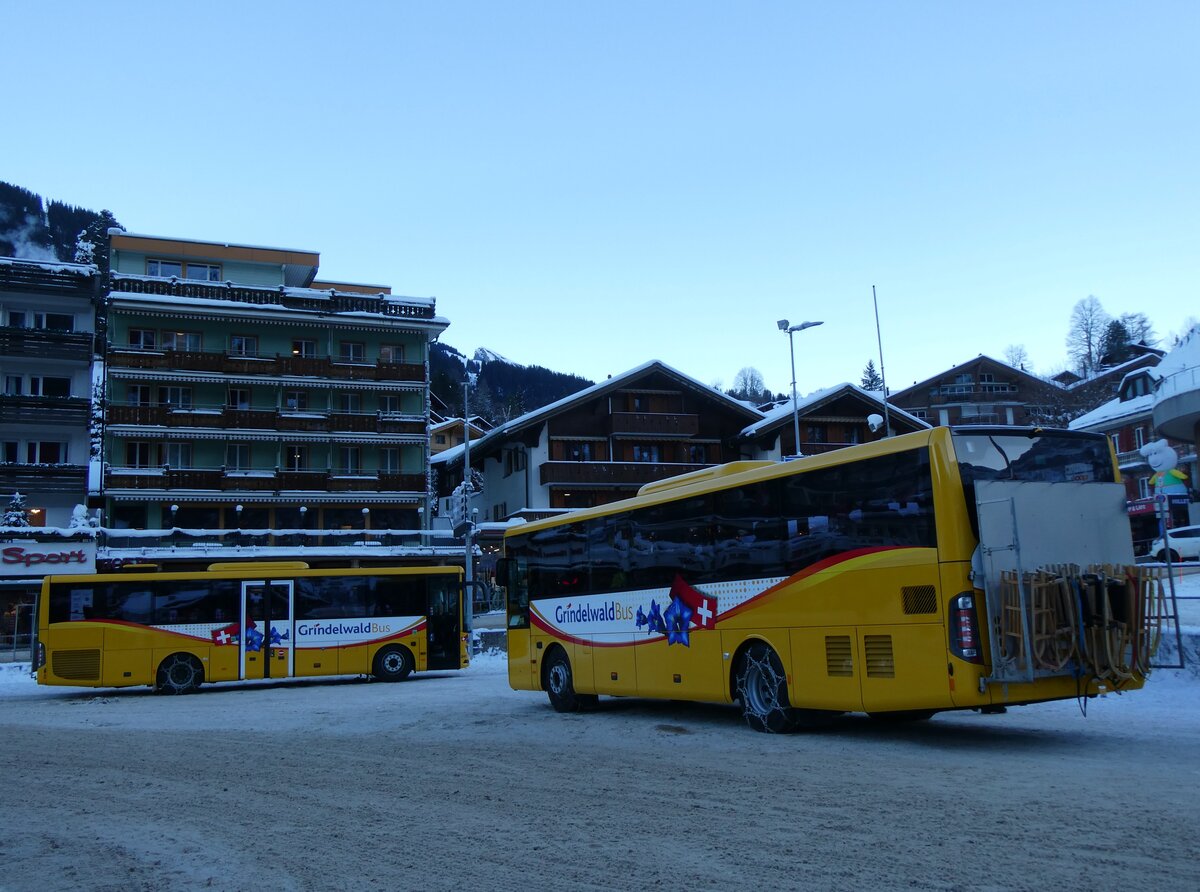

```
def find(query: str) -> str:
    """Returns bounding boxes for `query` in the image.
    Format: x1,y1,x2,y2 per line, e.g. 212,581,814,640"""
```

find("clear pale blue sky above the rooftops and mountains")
0,0,1200,391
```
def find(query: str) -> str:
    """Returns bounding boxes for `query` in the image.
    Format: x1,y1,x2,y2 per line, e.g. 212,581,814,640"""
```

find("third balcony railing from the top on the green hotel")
106,406,426,437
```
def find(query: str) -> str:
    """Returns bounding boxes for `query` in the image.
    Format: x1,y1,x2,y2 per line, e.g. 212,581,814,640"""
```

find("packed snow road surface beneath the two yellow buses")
0,659,1200,892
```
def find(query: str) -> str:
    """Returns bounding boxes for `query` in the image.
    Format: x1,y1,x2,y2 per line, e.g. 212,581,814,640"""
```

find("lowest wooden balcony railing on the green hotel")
104,467,425,493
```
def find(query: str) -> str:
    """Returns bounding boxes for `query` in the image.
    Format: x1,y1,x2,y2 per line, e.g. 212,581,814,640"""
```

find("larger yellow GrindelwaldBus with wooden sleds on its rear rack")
498,427,1154,731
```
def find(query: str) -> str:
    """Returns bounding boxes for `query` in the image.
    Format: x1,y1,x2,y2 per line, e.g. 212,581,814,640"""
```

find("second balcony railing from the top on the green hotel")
108,346,425,382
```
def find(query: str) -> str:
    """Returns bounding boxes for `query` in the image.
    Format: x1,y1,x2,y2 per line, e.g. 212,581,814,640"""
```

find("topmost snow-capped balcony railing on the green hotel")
112,274,434,319
